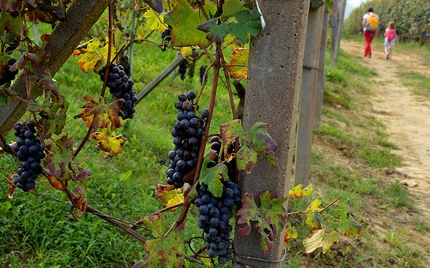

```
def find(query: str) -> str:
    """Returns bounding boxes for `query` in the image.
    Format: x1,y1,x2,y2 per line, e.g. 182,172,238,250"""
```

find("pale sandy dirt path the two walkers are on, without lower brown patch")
341,41,430,221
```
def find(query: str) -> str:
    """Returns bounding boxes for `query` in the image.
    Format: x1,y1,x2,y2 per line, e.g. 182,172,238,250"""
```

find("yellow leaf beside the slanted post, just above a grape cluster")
73,38,116,73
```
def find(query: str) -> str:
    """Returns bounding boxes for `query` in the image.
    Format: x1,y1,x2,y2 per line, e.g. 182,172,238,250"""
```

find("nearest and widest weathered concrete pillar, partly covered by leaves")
233,0,309,268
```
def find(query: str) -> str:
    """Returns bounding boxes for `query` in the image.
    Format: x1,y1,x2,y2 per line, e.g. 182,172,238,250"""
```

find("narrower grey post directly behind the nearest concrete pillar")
294,7,324,187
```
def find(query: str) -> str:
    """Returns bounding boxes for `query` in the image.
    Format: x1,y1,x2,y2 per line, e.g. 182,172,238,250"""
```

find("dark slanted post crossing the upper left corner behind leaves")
0,0,110,136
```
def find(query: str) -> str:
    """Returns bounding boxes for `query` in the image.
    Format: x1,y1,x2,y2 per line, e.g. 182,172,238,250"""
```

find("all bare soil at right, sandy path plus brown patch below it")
341,41,430,265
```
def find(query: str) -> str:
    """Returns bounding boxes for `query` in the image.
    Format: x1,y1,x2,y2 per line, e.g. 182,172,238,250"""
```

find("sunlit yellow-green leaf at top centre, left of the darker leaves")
165,0,210,48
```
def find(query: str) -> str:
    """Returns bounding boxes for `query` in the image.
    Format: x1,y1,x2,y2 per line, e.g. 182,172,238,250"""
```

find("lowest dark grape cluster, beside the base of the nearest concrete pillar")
193,180,240,264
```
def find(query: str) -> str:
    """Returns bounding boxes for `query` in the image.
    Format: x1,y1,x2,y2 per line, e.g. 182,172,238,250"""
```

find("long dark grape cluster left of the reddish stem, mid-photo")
167,91,209,188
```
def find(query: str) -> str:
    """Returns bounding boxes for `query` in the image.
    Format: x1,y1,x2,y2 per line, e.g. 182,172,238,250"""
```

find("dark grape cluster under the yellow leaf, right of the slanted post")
99,63,137,119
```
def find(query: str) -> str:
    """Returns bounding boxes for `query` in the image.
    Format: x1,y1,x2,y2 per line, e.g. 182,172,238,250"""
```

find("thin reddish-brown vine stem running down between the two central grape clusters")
176,43,222,226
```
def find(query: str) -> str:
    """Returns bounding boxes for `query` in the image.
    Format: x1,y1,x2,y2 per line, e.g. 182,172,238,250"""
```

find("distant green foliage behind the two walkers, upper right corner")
344,0,430,45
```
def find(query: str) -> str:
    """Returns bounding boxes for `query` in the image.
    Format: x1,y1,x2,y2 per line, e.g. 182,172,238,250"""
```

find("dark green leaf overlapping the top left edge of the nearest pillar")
229,10,261,43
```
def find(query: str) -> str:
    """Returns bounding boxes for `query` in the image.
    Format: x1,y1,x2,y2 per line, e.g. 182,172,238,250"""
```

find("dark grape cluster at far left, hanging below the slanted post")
13,121,45,191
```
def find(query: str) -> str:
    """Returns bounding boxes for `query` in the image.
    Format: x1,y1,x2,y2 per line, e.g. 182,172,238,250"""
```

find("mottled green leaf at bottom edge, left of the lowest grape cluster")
133,224,185,268
